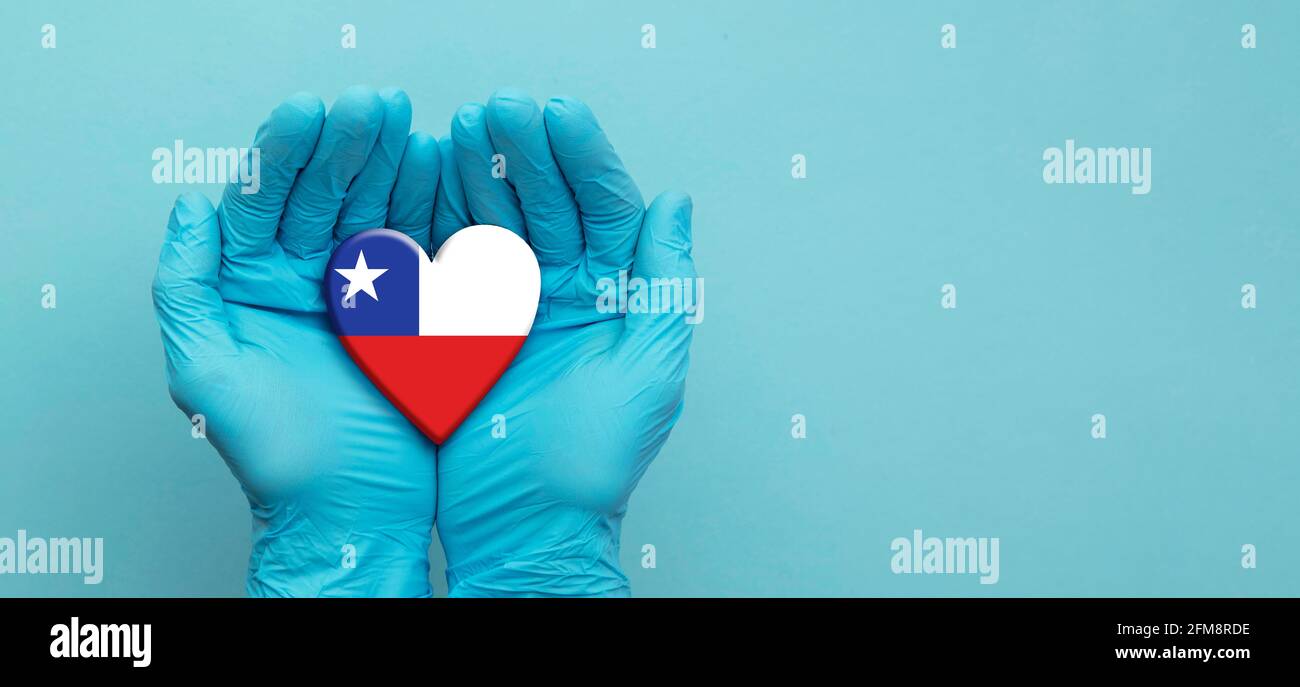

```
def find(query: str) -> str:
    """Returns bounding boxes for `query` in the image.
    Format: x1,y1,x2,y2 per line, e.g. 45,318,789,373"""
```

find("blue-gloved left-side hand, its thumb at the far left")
153,87,441,596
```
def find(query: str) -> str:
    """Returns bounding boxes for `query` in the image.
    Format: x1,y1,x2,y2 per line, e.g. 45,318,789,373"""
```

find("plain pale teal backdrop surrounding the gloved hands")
0,0,1300,596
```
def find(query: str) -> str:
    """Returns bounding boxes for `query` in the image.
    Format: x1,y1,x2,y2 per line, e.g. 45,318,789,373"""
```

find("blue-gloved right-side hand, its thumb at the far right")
434,90,696,596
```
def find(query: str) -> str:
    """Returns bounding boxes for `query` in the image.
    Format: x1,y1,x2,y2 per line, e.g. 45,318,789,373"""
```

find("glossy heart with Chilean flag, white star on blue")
325,225,541,444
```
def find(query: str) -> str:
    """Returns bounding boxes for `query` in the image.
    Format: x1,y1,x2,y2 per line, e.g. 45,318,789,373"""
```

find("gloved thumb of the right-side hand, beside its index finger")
619,191,703,376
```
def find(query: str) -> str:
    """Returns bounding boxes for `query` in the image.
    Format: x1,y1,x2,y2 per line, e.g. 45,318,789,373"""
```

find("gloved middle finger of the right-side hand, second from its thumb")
488,88,582,265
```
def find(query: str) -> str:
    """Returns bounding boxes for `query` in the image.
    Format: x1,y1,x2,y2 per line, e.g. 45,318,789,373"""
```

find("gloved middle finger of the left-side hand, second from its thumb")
280,86,384,259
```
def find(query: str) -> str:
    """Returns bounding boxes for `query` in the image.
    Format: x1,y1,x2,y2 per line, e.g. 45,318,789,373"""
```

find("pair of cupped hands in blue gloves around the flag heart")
153,87,696,596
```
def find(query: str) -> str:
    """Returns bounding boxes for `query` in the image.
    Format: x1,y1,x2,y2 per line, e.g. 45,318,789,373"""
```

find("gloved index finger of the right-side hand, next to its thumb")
546,98,645,277
